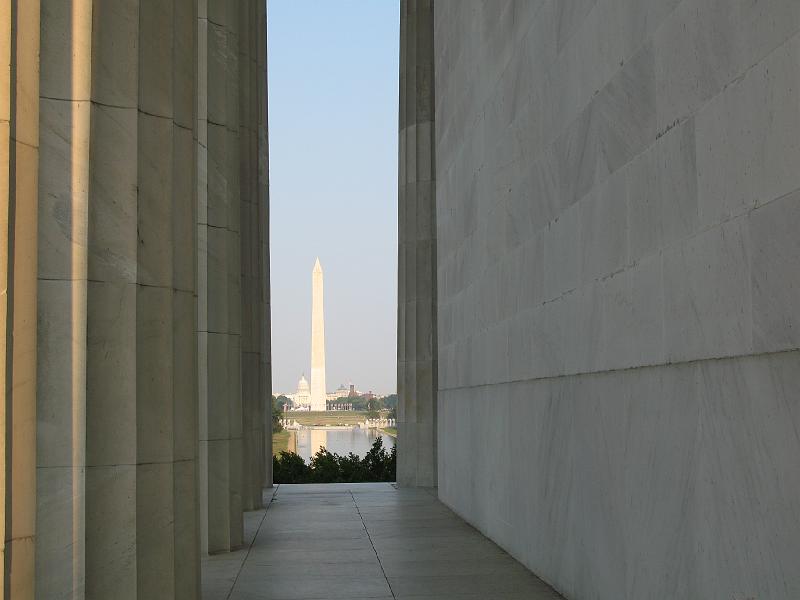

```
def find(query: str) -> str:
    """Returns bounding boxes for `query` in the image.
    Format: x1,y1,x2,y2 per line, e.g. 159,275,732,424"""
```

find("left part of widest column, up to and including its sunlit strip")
36,0,92,598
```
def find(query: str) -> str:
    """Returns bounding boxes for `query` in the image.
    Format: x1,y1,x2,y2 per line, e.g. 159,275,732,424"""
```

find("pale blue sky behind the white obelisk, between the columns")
267,0,400,393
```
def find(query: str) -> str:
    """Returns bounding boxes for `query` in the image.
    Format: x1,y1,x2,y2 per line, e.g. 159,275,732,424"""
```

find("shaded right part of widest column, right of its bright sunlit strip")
86,0,199,599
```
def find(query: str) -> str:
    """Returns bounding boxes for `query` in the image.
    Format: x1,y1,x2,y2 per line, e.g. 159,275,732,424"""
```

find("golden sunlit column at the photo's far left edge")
0,0,40,600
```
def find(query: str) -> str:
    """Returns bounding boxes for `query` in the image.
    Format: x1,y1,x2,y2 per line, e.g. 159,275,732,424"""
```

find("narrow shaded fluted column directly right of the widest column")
197,0,244,553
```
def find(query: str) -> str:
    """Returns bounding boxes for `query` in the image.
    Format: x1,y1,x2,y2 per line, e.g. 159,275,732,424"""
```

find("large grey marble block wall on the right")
434,0,800,600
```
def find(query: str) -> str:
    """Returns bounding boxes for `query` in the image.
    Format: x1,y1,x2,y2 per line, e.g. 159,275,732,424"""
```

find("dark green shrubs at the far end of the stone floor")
272,437,397,483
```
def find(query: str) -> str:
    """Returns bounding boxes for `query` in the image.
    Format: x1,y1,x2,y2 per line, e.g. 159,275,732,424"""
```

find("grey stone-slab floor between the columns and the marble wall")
203,483,561,600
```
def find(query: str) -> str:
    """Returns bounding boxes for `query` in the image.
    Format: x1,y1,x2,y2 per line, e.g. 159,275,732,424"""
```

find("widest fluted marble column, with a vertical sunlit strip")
36,0,199,600
